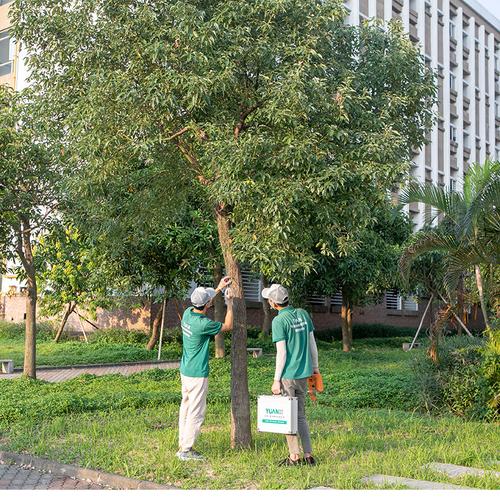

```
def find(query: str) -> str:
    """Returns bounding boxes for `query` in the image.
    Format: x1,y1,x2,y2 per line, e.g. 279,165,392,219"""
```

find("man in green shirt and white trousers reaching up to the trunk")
176,276,233,460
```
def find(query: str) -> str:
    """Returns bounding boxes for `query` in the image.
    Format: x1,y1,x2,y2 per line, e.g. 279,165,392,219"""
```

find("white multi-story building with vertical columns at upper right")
344,0,500,228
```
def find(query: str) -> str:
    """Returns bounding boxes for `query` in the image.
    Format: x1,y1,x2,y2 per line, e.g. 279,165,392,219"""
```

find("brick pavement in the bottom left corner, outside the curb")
0,461,112,488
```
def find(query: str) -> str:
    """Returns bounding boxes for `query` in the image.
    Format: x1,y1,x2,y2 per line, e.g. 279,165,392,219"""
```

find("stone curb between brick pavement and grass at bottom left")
0,451,178,490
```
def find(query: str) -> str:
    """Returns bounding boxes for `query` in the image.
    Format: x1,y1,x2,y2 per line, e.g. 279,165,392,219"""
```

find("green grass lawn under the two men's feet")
0,339,500,489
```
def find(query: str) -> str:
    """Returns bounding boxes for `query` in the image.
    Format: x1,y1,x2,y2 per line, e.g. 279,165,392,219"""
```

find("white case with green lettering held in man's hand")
257,396,298,434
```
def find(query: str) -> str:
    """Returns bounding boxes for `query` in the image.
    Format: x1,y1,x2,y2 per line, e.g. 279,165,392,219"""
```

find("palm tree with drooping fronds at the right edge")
400,160,500,328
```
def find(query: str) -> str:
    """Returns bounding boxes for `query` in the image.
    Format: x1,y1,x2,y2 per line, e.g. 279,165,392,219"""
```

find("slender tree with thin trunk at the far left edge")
0,86,59,378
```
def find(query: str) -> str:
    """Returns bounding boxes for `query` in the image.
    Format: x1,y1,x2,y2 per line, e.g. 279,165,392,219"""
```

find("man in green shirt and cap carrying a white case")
262,284,319,466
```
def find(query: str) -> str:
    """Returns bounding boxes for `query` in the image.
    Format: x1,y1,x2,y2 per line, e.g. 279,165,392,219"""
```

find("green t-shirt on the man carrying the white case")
272,306,314,379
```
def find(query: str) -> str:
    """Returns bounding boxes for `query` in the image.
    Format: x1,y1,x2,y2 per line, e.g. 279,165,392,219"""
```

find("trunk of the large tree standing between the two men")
217,208,252,448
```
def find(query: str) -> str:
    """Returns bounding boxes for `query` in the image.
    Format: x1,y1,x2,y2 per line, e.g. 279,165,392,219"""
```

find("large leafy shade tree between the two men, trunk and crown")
14,0,435,446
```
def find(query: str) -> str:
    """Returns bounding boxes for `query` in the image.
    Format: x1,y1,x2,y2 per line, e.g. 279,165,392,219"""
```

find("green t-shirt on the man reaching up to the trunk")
181,307,222,377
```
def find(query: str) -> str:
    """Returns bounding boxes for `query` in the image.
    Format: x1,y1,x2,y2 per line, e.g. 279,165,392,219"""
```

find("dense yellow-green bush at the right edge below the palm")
415,332,500,420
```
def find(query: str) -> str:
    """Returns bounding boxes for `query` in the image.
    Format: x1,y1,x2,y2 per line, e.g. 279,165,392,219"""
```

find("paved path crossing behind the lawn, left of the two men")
0,361,179,382
